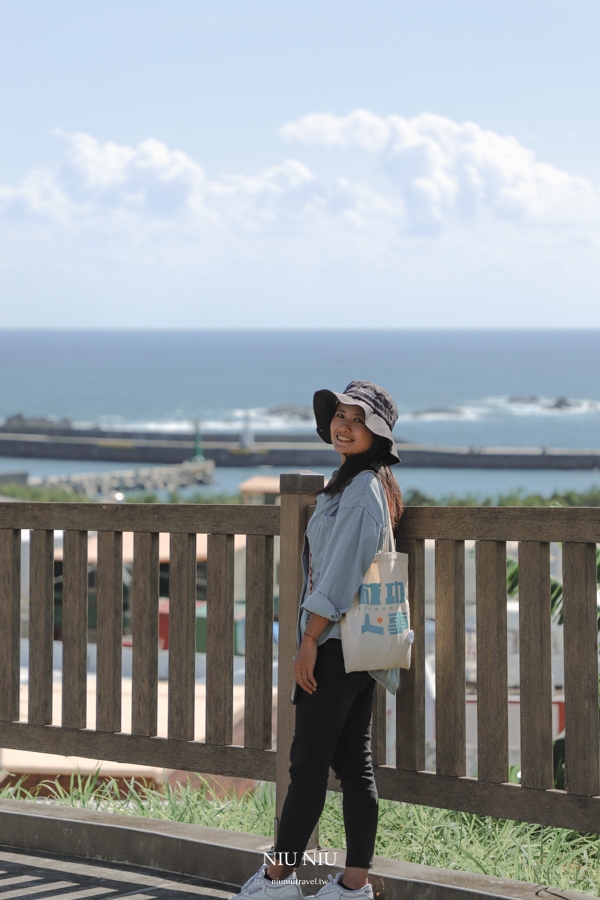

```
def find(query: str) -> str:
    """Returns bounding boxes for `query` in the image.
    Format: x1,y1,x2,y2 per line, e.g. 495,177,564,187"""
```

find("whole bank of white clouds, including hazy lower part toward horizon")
0,110,600,325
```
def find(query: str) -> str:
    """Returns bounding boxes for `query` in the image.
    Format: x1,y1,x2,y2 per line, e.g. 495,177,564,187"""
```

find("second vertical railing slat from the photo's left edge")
28,530,54,725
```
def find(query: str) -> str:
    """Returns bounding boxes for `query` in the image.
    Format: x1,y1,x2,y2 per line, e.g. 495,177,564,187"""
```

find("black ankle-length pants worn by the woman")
275,638,377,869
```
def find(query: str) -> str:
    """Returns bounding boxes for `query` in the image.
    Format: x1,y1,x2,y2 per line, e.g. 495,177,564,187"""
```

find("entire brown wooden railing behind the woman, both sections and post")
0,475,600,832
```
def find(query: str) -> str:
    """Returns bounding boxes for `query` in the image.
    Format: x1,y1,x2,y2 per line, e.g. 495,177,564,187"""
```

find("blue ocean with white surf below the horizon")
0,330,600,495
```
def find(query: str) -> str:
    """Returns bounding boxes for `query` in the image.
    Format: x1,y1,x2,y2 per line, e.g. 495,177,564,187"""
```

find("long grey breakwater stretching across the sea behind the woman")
0,424,600,471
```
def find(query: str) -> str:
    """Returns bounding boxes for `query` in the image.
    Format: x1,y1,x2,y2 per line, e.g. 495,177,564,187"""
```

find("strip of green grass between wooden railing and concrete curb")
0,775,600,895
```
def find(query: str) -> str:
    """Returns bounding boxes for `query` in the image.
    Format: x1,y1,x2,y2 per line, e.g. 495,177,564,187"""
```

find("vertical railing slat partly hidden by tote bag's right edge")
396,540,425,772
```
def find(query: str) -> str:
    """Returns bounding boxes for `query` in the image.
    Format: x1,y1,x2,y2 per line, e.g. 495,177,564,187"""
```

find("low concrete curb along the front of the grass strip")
0,800,598,900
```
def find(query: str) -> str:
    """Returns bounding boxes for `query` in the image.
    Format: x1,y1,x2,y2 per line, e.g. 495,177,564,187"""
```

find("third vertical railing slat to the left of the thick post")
169,534,196,741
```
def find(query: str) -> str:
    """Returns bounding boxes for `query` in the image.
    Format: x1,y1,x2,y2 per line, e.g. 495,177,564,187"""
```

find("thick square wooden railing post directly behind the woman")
275,474,325,831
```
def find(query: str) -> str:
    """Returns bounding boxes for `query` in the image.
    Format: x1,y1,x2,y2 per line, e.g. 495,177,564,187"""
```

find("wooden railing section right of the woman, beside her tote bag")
390,507,600,832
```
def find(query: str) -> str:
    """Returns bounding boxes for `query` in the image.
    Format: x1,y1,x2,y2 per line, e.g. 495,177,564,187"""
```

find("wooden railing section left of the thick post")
0,503,280,781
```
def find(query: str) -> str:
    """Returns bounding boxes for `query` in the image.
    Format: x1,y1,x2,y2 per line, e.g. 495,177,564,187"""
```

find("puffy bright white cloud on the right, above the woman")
280,110,599,230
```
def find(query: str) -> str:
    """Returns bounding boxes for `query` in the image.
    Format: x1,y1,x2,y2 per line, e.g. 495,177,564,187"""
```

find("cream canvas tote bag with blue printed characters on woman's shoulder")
340,509,414,672
